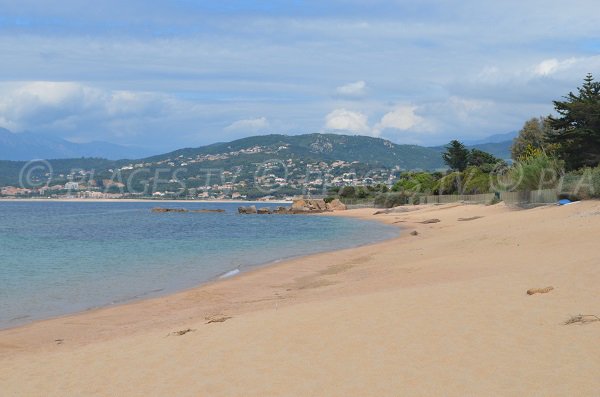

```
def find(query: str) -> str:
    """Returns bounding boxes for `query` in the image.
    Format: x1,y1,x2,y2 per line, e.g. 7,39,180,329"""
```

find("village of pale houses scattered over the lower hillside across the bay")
0,145,400,200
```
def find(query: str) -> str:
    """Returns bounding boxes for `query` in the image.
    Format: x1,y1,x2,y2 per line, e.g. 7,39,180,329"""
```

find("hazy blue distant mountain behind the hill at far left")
0,128,150,161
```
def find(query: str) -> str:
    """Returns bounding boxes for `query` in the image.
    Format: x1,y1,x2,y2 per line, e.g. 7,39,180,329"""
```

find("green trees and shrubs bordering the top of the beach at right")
326,74,600,207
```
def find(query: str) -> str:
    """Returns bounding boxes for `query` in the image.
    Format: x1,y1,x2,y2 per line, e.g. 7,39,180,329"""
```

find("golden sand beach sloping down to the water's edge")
0,201,600,396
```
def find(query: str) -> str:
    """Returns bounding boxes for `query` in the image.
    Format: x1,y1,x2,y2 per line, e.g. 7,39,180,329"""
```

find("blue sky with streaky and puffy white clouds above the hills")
0,0,600,151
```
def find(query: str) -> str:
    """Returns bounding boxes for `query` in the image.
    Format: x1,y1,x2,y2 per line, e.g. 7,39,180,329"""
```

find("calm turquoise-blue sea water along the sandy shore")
0,201,398,328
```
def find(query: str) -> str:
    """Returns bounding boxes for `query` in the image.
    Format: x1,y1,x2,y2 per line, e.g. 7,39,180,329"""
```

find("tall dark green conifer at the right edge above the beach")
549,74,600,169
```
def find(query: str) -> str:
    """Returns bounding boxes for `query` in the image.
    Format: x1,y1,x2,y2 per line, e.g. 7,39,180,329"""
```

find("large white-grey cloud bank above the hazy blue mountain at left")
0,81,179,141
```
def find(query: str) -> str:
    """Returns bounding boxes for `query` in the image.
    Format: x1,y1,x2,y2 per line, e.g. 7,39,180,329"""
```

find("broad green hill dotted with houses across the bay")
0,134,506,197
